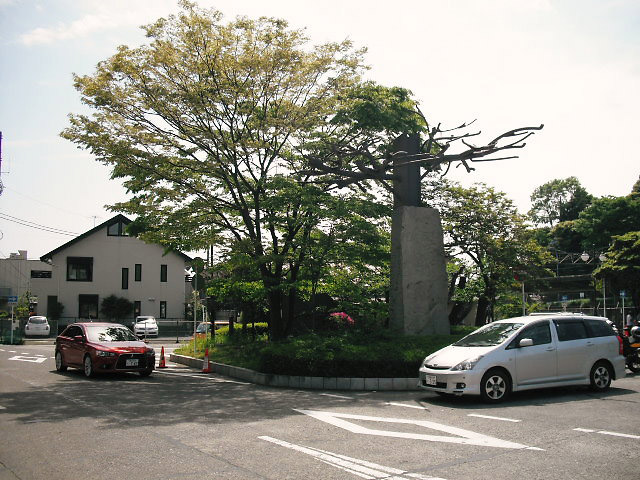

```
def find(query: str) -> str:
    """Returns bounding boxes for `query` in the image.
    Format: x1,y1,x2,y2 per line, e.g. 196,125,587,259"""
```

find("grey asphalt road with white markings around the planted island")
0,345,640,480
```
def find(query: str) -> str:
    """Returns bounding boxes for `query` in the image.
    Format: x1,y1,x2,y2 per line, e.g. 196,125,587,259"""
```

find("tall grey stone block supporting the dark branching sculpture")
390,206,450,335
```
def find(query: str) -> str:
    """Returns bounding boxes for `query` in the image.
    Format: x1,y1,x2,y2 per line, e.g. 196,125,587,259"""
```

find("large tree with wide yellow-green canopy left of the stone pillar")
62,2,419,338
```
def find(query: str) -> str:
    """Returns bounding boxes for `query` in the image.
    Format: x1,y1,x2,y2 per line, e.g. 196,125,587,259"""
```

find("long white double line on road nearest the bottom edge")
258,436,444,480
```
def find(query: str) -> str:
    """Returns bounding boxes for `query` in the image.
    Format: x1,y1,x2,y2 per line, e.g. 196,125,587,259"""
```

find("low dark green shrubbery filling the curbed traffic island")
176,323,477,378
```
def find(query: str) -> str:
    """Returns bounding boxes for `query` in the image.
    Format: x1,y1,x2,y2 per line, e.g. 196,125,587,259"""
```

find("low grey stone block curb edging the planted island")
169,353,420,391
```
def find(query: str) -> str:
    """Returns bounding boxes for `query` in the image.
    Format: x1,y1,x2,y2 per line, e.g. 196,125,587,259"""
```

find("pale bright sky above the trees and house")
0,0,640,259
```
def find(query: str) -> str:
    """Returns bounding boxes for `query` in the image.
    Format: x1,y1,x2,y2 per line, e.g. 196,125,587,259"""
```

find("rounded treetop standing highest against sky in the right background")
529,177,593,227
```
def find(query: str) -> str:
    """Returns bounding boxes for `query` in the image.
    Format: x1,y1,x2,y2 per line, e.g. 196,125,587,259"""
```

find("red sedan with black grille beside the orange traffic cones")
56,323,156,377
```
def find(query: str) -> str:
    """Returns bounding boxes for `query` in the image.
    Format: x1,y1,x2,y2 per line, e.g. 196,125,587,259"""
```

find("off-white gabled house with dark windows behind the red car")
31,215,191,320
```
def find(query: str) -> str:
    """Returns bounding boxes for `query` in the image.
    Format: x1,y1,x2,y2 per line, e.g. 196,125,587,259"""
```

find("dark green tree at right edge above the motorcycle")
593,231,640,307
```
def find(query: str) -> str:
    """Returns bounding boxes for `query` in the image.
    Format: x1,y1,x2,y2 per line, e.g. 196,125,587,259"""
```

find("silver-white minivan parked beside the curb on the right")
419,313,625,403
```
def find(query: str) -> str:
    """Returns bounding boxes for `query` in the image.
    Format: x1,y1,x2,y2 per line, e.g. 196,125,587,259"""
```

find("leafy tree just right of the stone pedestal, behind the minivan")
427,182,552,325
